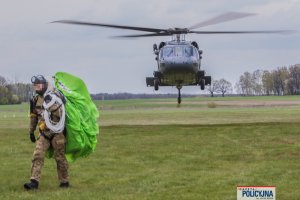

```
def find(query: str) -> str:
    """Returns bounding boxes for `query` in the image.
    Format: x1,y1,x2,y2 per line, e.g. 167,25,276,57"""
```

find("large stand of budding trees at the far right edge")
235,64,300,96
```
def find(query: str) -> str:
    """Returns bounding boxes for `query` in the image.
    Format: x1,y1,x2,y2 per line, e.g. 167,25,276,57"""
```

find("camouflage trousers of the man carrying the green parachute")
30,133,69,183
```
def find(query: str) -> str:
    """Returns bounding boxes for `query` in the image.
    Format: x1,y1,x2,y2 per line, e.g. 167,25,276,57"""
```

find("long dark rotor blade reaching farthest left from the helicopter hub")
51,20,166,33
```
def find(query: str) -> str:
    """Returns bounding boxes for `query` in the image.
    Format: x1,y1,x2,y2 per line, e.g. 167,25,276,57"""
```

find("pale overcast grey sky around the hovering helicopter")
0,0,300,94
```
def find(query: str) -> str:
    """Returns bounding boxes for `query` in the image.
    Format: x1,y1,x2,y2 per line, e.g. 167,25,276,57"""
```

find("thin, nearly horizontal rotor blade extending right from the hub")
189,30,295,34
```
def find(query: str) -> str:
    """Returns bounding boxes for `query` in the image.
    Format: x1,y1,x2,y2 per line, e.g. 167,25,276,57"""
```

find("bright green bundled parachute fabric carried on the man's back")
54,72,99,162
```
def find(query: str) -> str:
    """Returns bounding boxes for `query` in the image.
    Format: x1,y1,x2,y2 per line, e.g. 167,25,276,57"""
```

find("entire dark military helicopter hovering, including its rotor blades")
52,12,287,104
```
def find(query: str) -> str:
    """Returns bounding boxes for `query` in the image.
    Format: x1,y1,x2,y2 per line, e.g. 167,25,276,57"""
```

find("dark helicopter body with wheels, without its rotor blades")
146,34,207,104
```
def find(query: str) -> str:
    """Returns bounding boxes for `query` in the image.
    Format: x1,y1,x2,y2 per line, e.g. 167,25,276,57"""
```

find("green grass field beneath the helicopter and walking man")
0,96,300,200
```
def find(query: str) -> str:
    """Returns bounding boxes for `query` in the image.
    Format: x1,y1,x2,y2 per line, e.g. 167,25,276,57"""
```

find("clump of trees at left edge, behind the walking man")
0,75,33,105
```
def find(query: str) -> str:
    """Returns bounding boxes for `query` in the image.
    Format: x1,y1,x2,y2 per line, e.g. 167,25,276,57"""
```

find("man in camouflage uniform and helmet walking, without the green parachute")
24,75,69,190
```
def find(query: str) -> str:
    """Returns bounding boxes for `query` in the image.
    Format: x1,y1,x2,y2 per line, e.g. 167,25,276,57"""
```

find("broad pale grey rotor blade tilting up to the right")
188,12,255,30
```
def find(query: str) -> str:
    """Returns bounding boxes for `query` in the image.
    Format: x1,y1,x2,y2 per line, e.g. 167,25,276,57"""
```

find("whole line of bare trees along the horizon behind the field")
0,64,300,105
